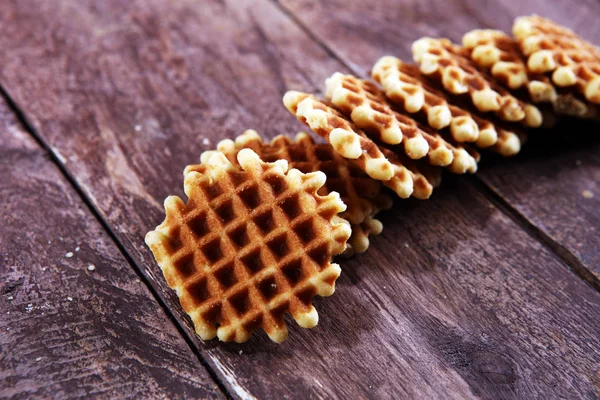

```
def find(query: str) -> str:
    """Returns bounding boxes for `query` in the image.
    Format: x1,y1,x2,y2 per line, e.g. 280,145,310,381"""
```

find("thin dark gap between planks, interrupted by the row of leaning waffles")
270,0,600,292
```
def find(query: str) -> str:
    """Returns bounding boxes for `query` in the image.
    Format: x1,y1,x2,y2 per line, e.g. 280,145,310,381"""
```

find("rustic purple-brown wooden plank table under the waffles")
0,0,600,399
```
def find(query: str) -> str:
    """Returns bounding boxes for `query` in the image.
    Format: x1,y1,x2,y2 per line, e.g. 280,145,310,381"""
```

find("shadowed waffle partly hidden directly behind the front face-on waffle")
184,130,394,253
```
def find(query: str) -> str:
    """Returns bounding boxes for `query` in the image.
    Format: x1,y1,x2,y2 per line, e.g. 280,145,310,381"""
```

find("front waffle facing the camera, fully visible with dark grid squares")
146,149,350,342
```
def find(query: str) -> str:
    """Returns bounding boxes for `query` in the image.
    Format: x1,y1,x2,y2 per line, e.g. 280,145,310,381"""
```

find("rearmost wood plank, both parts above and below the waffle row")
280,0,600,288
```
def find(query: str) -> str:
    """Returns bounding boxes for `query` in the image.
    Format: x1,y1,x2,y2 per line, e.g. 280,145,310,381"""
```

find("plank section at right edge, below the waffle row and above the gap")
484,125,600,288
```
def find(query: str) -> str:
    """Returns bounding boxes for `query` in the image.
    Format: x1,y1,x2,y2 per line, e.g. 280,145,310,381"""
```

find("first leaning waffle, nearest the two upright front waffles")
283,91,440,198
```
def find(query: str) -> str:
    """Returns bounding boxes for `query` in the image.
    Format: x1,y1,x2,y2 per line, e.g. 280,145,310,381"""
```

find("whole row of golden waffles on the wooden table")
146,16,600,342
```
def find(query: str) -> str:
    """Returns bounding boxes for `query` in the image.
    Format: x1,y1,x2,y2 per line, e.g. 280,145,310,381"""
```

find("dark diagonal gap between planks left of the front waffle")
0,84,234,399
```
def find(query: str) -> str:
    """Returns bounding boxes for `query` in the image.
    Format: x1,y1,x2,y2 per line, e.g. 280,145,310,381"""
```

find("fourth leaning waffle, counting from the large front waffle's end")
412,37,543,128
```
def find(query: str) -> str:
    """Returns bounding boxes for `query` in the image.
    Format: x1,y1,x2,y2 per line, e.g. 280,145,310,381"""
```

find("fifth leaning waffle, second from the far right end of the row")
462,29,596,118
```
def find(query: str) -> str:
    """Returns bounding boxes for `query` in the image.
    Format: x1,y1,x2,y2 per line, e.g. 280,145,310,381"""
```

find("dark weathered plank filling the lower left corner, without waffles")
0,102,223,398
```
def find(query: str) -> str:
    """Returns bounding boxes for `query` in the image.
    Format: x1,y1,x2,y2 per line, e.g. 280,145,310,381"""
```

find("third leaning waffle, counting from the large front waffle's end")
372,56,522,156
